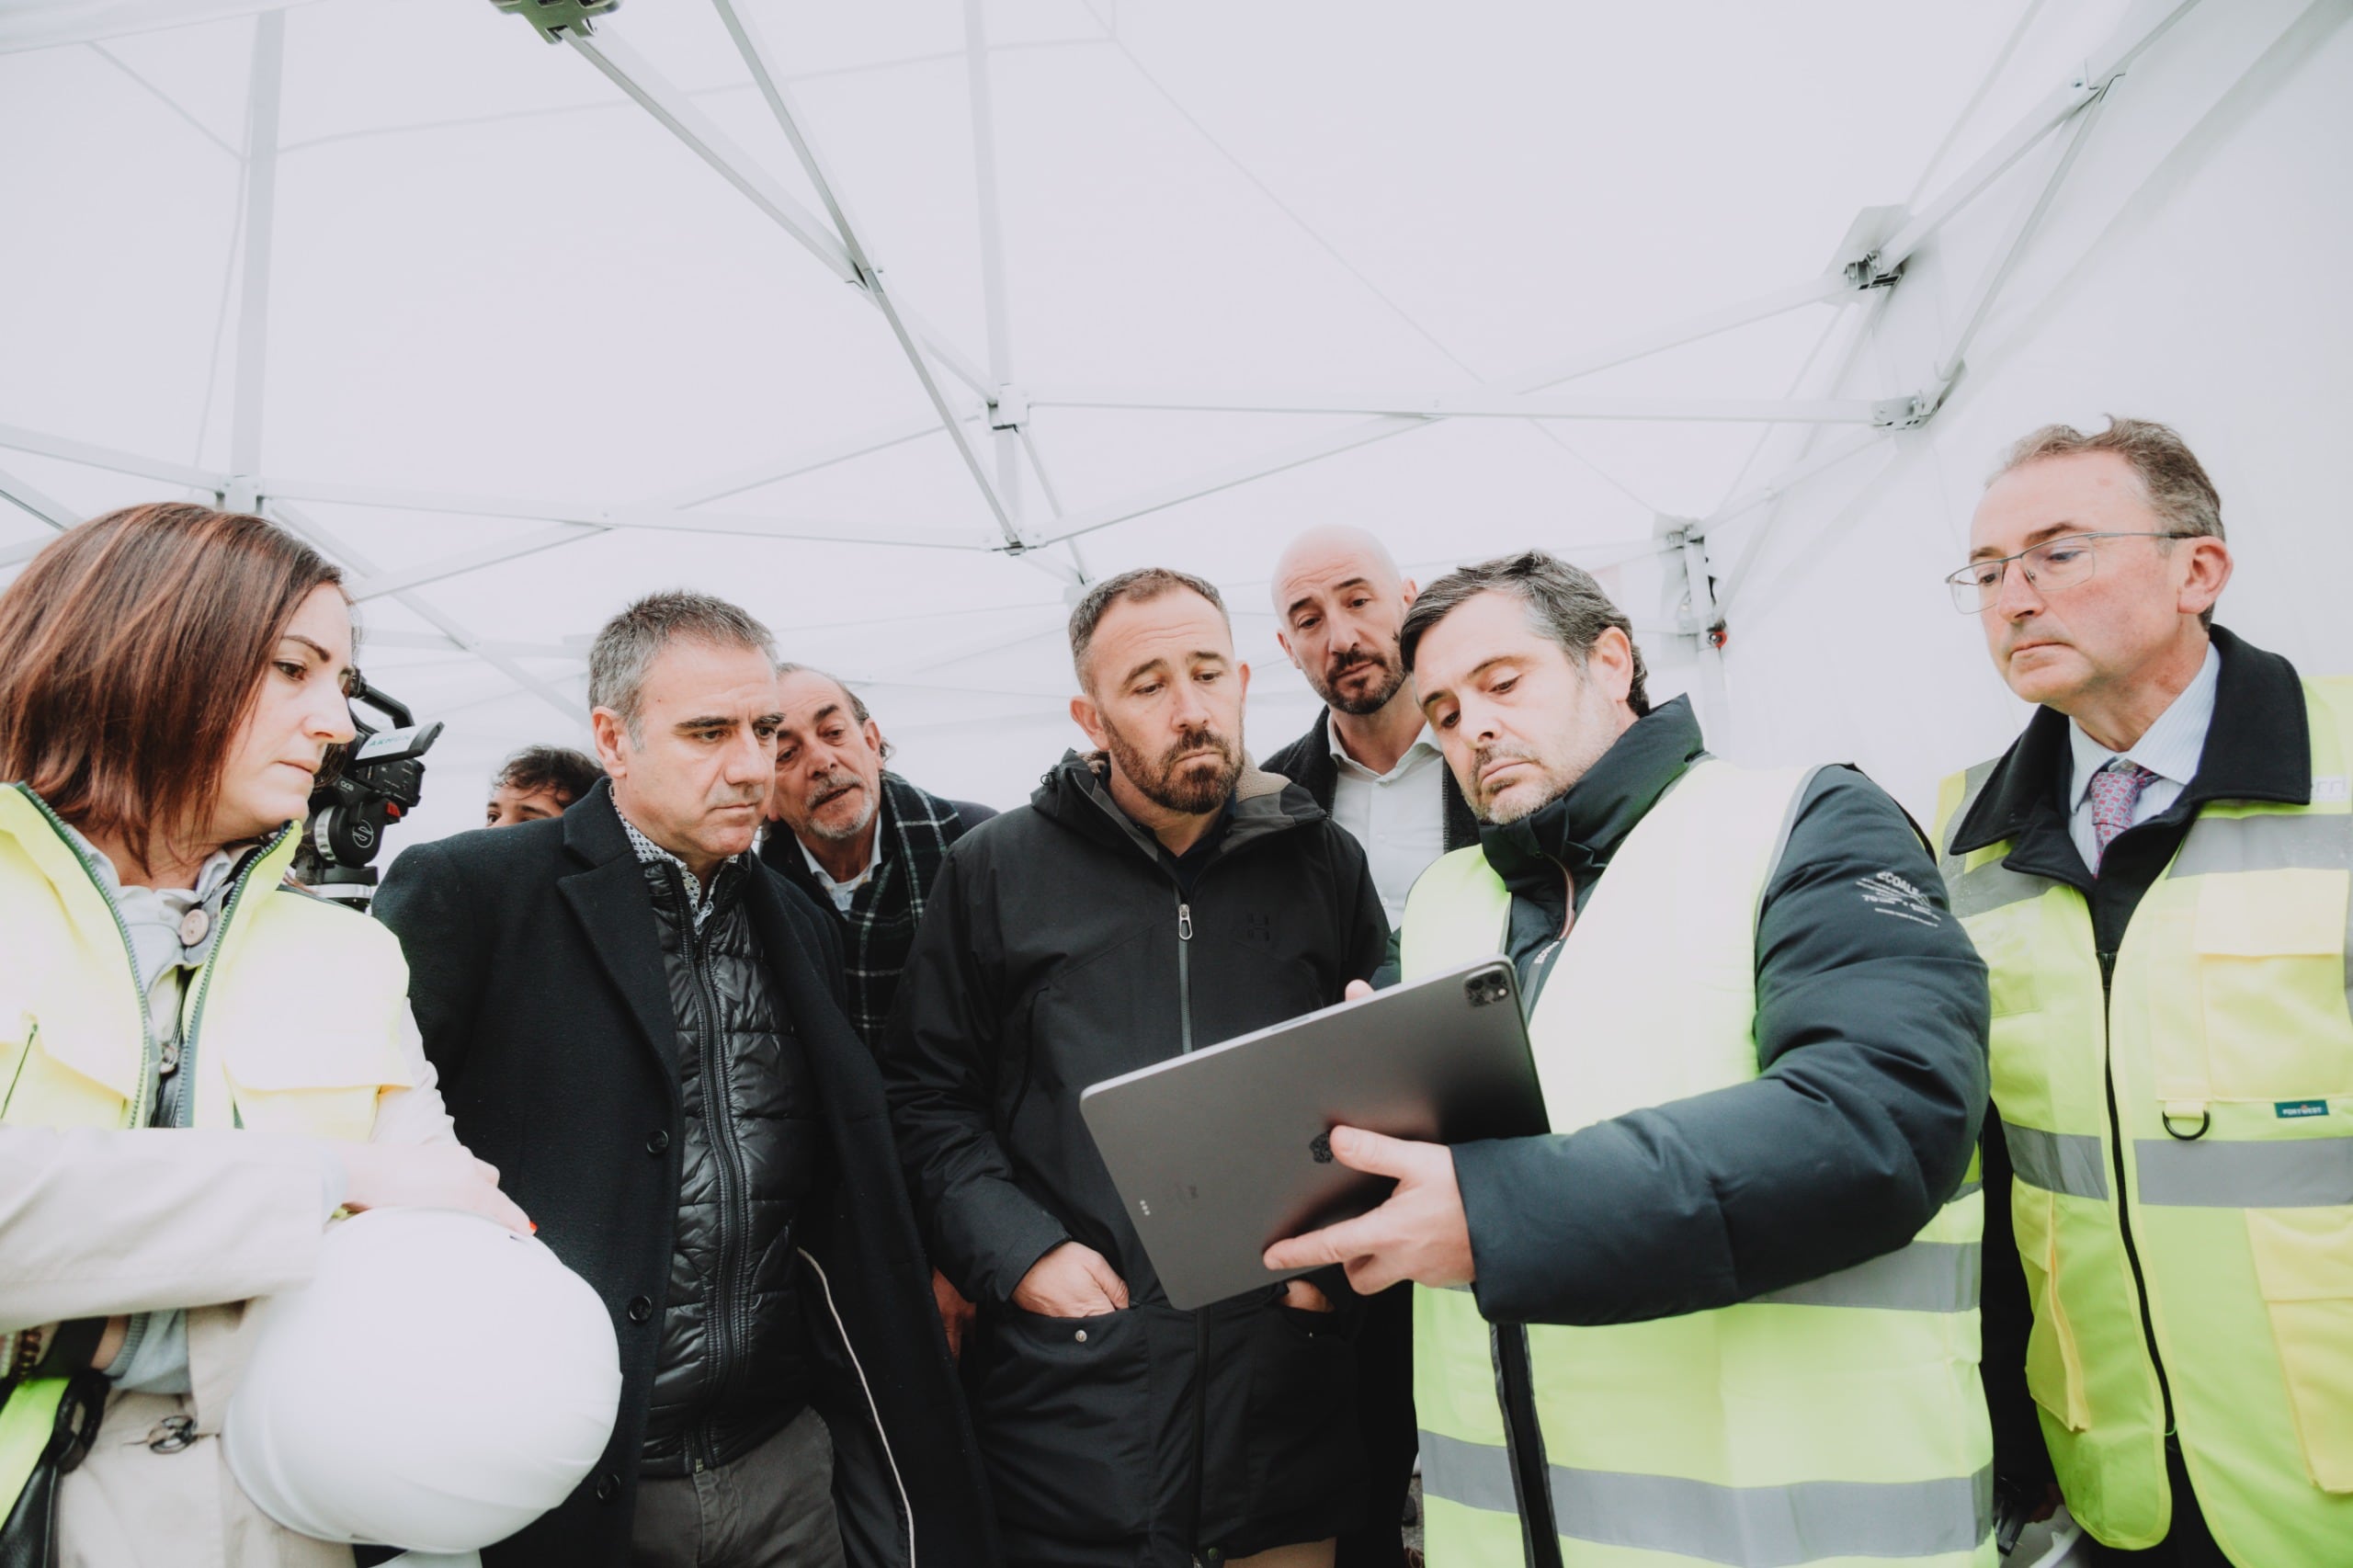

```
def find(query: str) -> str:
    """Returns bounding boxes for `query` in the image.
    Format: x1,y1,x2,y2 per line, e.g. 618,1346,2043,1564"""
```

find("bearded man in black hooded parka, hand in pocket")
882,567,1395,1568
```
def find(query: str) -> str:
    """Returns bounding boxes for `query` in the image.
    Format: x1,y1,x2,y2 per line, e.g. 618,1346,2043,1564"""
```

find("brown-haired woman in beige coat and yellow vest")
0,504,527,1568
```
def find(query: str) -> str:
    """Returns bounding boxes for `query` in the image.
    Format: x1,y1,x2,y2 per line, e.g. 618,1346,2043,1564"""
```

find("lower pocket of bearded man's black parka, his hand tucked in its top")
972,1307,1155,1544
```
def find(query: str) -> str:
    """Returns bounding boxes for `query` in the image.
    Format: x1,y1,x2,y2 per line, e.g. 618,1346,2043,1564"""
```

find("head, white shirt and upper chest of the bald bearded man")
1266,525,1478,926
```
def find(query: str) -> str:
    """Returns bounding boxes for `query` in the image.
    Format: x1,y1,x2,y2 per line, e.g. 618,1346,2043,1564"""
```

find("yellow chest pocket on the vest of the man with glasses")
2193,871,2353,1099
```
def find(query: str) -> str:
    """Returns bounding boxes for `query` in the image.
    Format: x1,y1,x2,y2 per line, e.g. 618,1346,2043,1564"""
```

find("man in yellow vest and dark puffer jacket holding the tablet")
1266,553,1993,1568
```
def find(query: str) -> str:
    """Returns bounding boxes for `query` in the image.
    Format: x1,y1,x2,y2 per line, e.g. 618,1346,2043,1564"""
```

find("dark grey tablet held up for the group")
1077,959,1551,1309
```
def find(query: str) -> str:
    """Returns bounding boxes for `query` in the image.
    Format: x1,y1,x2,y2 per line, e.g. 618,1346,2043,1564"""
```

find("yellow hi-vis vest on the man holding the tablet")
1403,760,1995,1568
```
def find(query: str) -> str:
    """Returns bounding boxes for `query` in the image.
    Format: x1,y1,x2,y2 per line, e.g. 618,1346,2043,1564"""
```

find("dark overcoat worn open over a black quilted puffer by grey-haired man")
377,784,997,1568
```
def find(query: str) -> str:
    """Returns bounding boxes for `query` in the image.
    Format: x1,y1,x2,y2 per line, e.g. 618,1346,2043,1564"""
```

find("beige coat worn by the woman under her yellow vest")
0,1036,457,1568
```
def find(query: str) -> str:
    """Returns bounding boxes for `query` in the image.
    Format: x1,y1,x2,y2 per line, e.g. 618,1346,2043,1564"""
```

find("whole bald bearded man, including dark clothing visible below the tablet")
1266,525,1478,1568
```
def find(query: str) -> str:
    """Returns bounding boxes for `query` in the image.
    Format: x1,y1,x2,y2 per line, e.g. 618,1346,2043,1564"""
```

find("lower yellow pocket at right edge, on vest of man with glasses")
2247,1206,2353,1493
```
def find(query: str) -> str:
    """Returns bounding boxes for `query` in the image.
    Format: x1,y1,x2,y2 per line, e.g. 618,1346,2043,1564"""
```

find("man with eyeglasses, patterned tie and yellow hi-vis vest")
1937,419,2353,1568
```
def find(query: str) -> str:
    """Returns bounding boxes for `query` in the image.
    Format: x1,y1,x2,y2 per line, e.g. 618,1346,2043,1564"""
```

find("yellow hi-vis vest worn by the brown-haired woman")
0,784,412,1517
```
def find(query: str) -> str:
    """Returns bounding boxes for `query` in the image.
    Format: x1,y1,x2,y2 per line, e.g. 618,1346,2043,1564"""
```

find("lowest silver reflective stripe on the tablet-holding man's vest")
1421,1431,1993,1568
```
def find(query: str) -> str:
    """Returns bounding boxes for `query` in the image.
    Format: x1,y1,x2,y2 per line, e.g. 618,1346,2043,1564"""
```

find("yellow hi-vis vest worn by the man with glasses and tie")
1937,680,2353,1568
